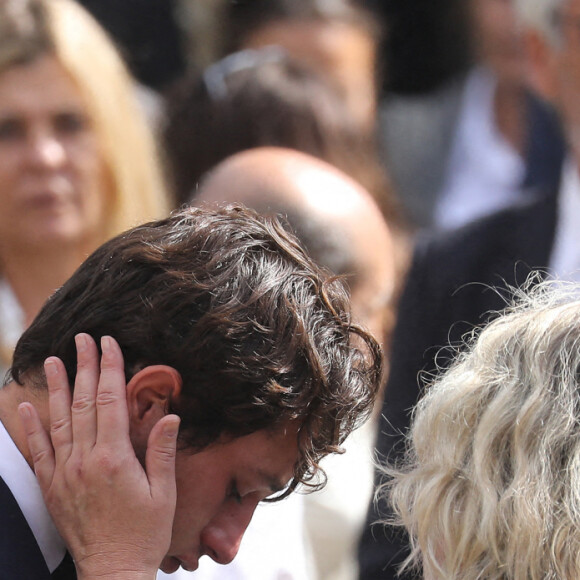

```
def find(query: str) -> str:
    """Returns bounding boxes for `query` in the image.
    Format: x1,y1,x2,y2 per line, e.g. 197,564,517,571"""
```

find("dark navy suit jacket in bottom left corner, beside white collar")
0,477,50,580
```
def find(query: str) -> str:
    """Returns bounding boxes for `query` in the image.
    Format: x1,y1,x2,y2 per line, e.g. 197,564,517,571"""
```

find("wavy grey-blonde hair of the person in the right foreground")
383,283,580,580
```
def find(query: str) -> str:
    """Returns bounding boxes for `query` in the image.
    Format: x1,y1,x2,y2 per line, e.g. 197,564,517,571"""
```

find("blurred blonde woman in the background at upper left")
0,0,169,378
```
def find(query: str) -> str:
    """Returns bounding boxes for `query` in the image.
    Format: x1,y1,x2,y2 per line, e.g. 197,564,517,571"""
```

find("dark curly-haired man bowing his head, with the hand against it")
0,207,382,580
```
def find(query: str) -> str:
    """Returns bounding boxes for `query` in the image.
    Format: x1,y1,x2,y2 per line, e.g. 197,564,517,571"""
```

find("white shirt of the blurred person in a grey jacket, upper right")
434,68,525,229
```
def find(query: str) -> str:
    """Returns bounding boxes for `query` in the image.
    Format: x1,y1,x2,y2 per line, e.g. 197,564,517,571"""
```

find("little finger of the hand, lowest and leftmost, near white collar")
18,403,55,493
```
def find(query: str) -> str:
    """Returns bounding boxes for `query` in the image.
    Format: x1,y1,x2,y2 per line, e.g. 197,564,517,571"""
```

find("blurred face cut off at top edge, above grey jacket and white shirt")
471,0,524,83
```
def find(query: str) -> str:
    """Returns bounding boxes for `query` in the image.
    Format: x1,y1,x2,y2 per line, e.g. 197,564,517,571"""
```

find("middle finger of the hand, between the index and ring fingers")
71,333,99,452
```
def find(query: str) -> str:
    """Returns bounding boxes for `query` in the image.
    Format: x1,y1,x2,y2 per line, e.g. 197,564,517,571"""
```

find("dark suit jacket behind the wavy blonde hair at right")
359,195,557,580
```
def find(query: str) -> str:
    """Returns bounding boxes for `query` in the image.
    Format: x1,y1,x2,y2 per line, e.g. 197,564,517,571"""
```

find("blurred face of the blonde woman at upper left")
0,55,106,255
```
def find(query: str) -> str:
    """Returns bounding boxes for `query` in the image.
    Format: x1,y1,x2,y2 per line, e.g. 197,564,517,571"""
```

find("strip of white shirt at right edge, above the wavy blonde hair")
549,159,580,282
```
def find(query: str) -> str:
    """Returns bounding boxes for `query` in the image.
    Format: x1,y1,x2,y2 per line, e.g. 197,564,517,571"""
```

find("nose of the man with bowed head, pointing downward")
201,499,257,564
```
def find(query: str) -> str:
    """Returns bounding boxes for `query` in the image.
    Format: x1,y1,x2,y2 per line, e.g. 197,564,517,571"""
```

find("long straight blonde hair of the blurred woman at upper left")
0,0,169,241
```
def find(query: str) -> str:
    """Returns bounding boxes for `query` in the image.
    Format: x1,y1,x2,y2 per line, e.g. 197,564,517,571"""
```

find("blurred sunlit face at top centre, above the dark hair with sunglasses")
244,21,376,129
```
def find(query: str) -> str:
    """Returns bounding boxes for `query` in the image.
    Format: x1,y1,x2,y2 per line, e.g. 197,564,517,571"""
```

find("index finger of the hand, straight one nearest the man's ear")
97,336,130,447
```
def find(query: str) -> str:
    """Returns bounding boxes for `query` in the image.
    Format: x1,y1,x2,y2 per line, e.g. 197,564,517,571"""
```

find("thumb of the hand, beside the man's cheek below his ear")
145,415,180,509
